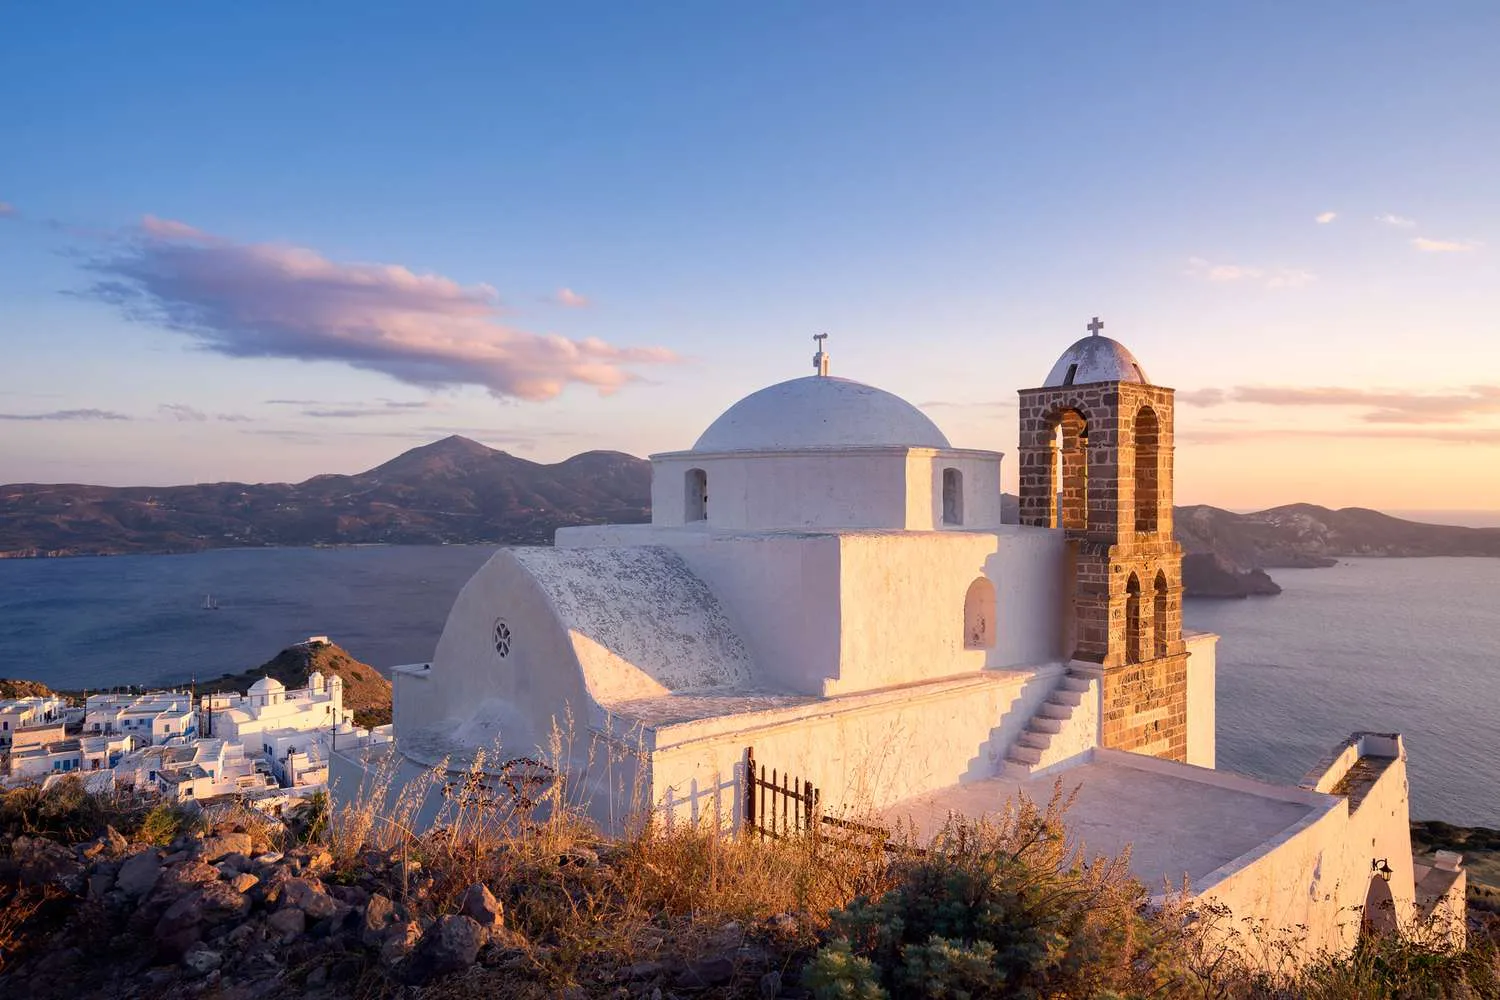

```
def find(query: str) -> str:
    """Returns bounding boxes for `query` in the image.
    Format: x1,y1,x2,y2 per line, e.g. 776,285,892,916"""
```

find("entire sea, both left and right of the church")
0,546,1500,828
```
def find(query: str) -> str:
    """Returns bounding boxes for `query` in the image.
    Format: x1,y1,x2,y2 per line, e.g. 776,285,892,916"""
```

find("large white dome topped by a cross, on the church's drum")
693,375,951,451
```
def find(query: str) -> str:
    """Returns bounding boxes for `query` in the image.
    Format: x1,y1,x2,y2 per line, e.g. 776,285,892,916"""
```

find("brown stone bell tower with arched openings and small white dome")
1020,316,1188,760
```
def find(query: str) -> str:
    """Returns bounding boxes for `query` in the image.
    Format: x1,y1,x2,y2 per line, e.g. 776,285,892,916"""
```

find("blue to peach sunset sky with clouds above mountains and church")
0,0,1500,510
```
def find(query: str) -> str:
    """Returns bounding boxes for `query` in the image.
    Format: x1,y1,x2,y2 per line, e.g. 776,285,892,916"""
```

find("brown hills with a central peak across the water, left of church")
0,436,651,556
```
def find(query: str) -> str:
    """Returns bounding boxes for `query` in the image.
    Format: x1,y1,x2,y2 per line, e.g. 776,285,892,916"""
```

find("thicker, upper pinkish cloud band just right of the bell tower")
1178,385,1500,424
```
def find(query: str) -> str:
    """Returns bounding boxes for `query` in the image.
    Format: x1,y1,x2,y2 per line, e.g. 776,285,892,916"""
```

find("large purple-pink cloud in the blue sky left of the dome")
84,216,677,400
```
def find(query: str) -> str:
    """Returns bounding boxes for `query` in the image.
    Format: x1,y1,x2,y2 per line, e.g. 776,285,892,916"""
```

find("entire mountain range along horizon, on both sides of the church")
0,436,1500,597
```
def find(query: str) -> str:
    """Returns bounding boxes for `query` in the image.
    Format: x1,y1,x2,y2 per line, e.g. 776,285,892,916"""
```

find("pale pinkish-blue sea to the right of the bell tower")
1184,559,1500,826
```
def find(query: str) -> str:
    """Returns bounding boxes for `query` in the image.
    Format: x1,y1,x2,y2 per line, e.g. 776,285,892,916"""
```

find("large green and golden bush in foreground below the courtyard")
809,790,1176,999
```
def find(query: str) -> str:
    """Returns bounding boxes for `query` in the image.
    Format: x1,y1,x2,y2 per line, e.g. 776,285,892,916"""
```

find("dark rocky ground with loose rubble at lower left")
0,828,806,1000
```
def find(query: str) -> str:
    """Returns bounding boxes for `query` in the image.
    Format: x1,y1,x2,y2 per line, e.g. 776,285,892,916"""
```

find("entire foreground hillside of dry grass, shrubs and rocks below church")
0,778,1500,1000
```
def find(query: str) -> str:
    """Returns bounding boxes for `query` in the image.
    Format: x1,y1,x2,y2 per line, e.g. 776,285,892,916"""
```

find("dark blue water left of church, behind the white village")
0,546,495,690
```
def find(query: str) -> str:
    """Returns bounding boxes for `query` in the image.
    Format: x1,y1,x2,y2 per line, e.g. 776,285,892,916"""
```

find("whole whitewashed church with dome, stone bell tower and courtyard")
332,319,1464,955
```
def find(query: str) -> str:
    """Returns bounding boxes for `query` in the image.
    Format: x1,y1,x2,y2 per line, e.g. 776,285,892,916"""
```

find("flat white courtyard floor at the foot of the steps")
884,751,1329,892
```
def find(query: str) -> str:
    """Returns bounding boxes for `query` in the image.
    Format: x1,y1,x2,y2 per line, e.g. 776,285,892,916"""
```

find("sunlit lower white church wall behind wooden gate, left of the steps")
651,666,1062,825
